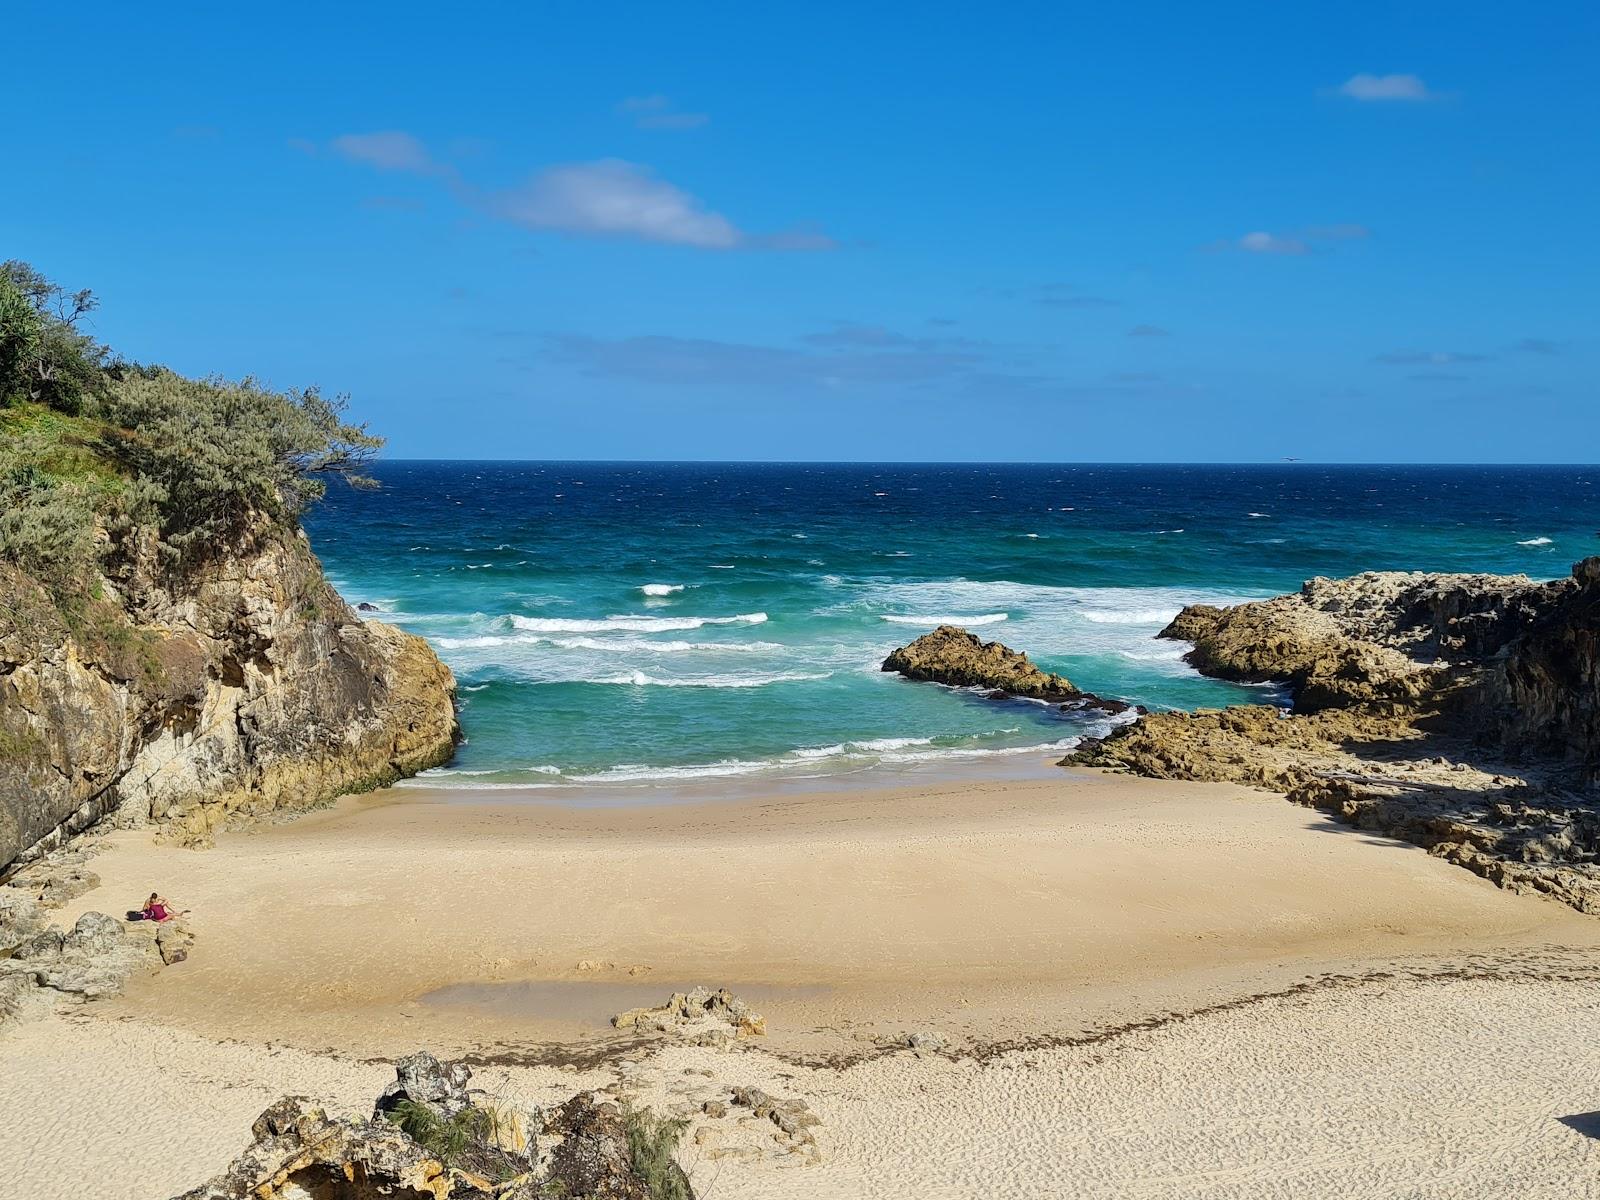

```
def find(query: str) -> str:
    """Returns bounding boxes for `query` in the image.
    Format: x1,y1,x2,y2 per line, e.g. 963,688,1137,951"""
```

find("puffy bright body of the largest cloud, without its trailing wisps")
491,158,746,250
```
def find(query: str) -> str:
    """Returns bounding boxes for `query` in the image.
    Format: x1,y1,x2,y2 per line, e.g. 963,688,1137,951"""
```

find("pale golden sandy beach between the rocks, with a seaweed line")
0,773,1600,1200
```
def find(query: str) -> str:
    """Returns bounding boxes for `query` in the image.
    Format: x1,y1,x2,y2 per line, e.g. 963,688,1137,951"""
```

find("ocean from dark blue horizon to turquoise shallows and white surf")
307,462,1600,787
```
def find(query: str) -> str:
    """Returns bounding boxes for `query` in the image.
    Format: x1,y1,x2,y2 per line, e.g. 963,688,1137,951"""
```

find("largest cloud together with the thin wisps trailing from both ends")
318,130,838,251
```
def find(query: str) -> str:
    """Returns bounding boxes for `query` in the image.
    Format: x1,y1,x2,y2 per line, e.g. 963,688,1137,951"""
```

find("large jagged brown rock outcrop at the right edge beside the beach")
1064,558,1600,912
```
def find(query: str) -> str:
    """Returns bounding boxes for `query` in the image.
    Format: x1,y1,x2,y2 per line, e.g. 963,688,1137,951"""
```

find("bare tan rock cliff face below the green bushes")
0,530,456,869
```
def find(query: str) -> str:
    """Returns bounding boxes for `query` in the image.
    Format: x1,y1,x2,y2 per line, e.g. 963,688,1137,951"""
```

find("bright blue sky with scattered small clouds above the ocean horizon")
0,0,1600,462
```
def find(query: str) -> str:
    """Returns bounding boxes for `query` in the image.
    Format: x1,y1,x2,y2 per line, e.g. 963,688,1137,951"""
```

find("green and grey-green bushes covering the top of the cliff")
0,259,382,582
